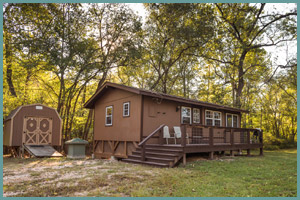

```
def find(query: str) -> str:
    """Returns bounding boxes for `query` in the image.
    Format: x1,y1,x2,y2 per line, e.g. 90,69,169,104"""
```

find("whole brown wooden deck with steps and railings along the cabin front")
123,124,263,167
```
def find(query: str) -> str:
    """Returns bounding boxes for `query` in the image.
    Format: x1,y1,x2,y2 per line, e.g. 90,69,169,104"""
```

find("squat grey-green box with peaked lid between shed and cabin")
65,138,89,159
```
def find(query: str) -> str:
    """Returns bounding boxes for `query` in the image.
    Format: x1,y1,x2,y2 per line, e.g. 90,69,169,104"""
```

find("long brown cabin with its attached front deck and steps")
84,82,262,167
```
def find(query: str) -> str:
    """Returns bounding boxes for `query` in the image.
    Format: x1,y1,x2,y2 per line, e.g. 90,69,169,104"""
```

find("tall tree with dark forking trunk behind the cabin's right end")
204,3,297,107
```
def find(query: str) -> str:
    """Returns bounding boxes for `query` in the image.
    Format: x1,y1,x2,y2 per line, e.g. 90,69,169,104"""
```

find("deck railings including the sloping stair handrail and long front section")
139,124,263,161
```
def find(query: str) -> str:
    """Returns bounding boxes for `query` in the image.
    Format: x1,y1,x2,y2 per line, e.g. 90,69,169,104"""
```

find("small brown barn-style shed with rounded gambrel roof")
3,104,62,147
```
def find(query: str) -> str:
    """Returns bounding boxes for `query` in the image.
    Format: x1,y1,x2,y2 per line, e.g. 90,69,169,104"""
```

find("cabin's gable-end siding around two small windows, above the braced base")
94,89,141,141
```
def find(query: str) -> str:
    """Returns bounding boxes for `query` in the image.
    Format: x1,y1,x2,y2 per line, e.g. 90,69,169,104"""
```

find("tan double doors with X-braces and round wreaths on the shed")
23,117,52,145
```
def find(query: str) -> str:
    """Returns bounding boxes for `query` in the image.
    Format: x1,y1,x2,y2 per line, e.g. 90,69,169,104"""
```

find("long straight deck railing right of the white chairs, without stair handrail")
181,125,263,146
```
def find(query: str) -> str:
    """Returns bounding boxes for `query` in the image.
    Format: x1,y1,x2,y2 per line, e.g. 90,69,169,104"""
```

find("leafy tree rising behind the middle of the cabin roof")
144,4,214,93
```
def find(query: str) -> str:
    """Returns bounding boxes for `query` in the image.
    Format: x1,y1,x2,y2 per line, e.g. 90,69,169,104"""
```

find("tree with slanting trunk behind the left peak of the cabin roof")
83,4,142,138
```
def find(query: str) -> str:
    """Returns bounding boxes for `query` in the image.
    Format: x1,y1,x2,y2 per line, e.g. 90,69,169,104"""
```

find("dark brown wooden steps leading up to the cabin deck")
122,144,183,167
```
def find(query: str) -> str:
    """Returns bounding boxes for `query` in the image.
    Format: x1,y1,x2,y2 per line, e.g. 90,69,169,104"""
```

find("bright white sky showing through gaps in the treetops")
127,3,297,66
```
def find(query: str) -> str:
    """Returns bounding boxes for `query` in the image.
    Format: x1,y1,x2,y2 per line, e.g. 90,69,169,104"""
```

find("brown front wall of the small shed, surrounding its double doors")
12,105,61,146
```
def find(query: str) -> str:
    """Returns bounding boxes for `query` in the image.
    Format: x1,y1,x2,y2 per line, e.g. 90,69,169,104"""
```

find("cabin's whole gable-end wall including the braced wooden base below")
94,88,142,158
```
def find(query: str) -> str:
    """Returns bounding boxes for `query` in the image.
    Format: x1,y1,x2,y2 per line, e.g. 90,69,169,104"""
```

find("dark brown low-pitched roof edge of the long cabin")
84,82,249,113
